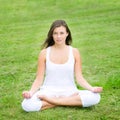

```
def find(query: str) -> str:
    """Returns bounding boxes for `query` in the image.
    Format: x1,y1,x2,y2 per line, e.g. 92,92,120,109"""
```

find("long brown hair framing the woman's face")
42,20,72,48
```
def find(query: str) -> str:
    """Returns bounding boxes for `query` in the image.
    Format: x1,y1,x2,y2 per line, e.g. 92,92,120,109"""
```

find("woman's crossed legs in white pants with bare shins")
22,90,100,112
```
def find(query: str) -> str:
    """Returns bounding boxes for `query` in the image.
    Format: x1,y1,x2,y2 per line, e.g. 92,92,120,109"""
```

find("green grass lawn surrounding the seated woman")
0,0,120,120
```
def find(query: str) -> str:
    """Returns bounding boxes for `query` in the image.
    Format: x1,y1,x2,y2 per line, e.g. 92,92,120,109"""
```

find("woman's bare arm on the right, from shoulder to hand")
73,48,102,92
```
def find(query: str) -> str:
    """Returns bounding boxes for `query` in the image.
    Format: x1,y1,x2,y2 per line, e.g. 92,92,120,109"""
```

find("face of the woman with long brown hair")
53,26,68,45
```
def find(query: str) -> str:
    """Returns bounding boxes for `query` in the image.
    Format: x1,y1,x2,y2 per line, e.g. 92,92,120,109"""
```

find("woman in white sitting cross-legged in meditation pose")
22,20,102,112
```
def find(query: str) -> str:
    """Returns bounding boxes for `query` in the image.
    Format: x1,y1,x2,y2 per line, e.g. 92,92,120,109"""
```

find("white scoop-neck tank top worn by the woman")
41,46,77,92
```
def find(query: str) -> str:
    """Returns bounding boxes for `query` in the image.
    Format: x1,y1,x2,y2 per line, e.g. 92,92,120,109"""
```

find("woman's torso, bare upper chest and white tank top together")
42,46,76,92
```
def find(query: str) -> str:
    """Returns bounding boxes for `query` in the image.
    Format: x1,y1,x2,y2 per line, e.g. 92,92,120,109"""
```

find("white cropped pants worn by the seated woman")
22,90,100,112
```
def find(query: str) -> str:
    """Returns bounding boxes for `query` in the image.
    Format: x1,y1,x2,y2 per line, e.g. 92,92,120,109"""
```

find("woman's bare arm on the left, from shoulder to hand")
22,50,46,98
